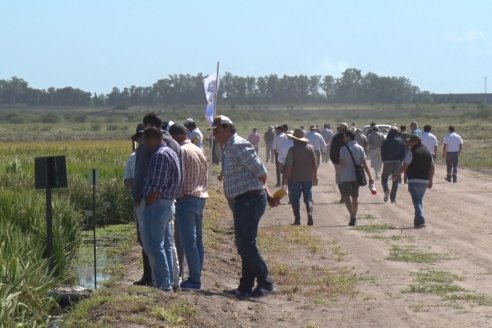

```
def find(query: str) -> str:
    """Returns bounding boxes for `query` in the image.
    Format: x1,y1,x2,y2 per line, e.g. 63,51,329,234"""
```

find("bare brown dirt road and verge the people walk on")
77,163,492,328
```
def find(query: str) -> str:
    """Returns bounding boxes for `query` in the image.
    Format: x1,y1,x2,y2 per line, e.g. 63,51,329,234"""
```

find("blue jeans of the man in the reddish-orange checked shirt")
175,196,207,282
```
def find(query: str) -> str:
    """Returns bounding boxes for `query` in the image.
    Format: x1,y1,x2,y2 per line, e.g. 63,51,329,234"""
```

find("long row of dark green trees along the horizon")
0,68,468,108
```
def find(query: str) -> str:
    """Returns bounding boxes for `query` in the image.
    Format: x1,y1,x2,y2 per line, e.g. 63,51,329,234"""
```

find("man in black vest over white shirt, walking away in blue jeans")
393,134,434,229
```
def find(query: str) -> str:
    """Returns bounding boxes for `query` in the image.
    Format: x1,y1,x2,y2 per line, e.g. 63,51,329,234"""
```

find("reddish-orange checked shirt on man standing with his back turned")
178,139,208,198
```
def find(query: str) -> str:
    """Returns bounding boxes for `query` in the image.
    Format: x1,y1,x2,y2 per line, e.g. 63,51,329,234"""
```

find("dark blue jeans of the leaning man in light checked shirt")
230,191,272,292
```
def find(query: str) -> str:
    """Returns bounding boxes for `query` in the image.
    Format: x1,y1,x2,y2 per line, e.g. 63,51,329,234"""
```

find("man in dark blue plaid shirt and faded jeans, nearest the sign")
142,126,182,291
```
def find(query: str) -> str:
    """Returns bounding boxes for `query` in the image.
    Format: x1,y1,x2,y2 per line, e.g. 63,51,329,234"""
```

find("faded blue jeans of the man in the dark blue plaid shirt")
141,199,174,290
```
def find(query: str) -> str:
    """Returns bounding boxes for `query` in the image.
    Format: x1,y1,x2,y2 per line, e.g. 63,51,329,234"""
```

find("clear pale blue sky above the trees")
0,0,492,93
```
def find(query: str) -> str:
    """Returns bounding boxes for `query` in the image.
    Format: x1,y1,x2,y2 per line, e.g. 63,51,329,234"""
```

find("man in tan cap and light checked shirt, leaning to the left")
211,115,279,298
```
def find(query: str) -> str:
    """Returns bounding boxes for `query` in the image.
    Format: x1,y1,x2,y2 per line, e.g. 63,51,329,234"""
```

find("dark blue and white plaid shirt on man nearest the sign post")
143,144,182,199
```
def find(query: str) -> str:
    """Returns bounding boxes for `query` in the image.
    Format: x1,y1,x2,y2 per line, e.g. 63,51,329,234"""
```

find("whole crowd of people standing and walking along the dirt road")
124,113,463,299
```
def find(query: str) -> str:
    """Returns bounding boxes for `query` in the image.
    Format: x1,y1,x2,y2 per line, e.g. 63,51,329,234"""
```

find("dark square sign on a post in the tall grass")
34,156,67,270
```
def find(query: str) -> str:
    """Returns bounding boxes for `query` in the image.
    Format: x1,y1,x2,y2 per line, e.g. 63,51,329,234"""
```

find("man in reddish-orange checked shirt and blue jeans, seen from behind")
169,123,208,290
